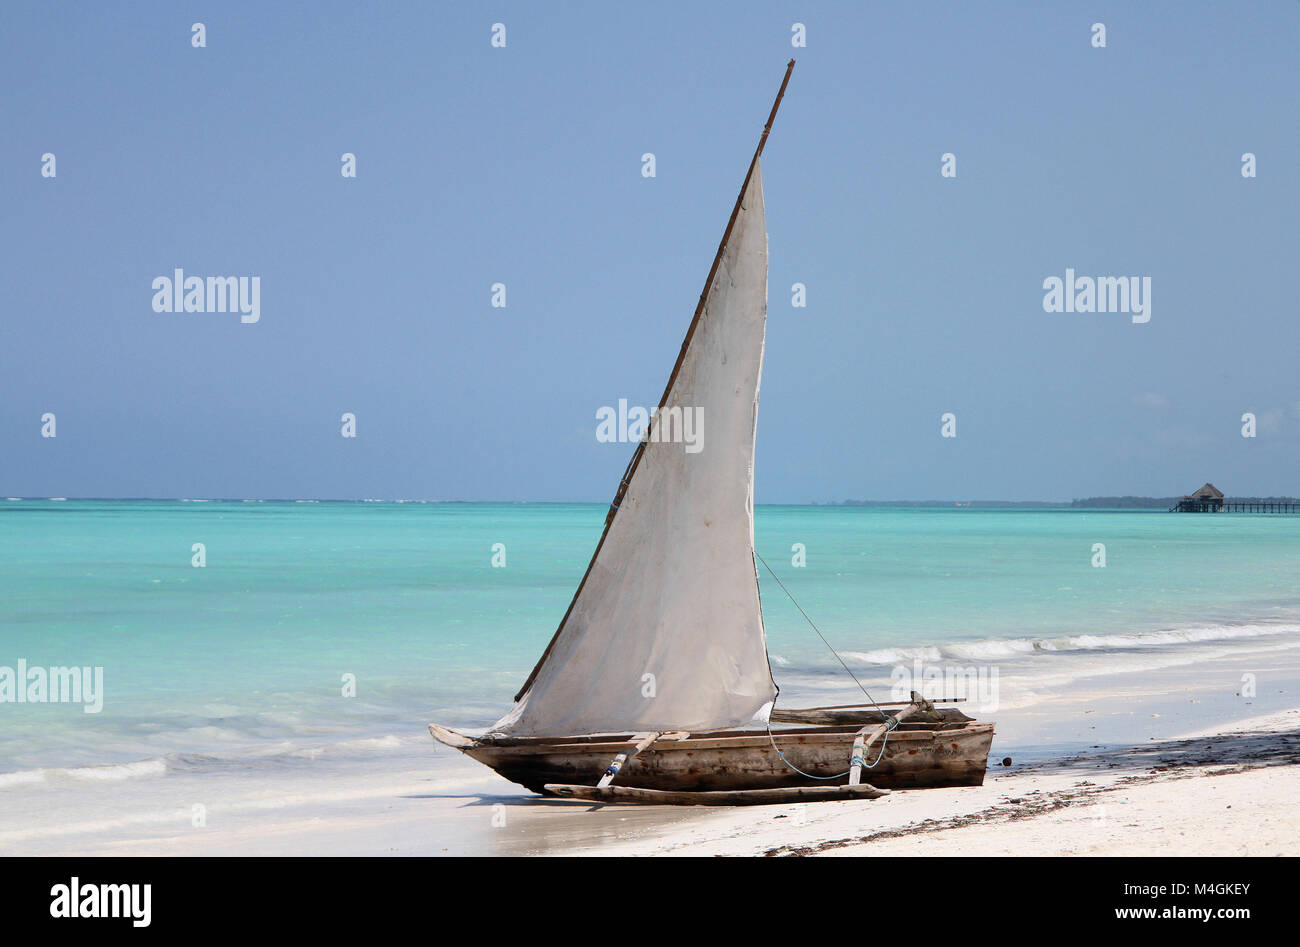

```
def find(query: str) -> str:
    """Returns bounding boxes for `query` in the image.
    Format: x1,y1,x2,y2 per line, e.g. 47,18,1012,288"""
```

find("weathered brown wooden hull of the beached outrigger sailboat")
430,719,993,795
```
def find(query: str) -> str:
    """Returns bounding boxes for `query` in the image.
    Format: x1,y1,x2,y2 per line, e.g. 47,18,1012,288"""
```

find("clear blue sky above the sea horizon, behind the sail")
0,0,1300,502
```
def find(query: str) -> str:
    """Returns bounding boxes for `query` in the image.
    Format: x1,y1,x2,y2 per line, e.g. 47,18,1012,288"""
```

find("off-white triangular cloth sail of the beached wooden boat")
491,159,776,736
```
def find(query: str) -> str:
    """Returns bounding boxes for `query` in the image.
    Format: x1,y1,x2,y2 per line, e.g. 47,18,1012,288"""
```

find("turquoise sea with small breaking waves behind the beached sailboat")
0,500,1300,775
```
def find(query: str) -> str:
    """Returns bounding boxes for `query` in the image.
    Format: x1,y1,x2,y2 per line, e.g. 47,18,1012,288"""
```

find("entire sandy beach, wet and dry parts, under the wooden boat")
0,643,1300,856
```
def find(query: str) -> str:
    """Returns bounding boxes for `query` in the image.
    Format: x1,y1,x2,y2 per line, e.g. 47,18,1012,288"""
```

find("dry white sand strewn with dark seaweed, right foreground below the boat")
586,709,1300,856
